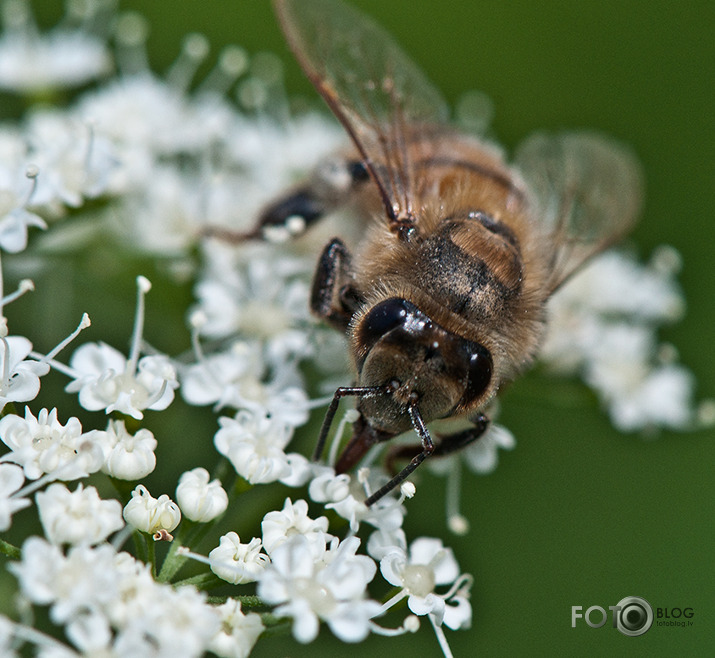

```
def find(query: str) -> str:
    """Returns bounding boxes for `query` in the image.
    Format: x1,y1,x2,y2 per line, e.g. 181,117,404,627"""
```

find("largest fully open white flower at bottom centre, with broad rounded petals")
258,535,381,643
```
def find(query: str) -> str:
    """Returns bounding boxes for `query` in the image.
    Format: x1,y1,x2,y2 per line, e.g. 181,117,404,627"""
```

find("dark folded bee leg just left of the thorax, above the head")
310,238,362,332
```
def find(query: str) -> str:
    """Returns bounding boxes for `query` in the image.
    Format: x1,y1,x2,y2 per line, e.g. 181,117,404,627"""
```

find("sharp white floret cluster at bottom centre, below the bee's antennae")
199,499,471,643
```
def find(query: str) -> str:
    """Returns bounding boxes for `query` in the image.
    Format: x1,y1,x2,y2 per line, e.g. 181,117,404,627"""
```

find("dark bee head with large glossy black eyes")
353,297,492,432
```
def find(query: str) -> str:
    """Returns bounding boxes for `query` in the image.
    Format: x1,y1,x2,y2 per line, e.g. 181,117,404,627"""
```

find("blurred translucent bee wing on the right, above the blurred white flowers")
516,133,643,292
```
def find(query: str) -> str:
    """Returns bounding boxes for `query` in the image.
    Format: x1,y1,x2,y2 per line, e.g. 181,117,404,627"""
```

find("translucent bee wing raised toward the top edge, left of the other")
273,0,448,221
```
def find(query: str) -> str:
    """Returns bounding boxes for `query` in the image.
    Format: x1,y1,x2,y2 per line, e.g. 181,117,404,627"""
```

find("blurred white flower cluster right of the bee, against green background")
541,247,697,432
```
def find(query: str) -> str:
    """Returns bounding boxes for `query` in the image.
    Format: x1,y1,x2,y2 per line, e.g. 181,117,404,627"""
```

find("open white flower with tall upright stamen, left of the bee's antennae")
65,342,179,419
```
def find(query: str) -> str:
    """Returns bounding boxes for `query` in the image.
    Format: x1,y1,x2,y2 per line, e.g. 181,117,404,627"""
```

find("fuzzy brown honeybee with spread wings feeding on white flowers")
238,0,642,506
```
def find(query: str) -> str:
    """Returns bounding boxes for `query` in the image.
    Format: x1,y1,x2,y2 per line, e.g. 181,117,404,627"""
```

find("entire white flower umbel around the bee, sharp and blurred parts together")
0,0,708,657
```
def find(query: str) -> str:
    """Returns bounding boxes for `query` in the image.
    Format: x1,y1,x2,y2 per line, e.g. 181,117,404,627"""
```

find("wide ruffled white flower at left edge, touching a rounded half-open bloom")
0,408,103,480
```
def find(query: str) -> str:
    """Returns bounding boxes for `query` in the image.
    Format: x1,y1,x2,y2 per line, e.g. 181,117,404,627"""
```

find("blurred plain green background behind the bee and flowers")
11,0,715,657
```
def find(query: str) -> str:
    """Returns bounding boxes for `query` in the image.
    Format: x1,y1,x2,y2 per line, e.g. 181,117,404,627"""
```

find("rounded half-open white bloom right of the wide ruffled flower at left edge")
102,420,157,480
